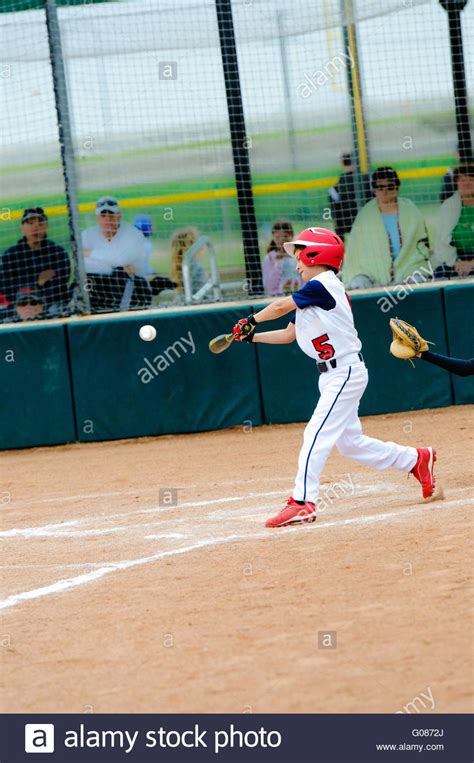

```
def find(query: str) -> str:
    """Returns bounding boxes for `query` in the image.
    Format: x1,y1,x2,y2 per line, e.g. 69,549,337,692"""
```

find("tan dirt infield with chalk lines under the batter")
0,406,473,713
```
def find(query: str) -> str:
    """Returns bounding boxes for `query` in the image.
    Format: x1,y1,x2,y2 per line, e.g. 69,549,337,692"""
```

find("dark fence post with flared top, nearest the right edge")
440,0,472,161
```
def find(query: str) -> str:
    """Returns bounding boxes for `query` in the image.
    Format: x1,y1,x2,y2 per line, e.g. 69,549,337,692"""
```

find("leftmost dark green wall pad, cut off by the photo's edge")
0,325,76,450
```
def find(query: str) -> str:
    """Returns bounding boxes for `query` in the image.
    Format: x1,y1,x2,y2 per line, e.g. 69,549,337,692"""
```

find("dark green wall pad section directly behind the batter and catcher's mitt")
256,289,453,423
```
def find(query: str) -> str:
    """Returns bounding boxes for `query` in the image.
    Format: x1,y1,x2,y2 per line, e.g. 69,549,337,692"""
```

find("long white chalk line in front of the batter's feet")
0,499,470,609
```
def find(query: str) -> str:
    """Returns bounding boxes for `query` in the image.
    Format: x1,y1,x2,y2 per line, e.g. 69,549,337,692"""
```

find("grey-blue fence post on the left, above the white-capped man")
45,0,91,313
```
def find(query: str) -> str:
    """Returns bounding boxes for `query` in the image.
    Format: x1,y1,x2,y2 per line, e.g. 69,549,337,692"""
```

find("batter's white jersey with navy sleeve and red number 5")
292,270,362,363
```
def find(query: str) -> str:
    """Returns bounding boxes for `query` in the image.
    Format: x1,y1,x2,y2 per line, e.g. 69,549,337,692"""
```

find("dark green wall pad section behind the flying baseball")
68,305,262,441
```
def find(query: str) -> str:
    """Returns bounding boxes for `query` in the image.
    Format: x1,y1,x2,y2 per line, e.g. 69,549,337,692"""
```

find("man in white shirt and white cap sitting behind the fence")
82,196,151,311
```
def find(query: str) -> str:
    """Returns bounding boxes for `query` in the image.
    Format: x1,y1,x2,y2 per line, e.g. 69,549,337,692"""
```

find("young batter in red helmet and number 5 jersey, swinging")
232,228,436,527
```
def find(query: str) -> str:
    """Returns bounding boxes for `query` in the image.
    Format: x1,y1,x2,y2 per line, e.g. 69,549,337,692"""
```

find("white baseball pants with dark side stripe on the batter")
293,355,418,503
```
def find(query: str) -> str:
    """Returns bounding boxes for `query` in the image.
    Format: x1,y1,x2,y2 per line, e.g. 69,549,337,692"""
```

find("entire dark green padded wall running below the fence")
0,284,474,449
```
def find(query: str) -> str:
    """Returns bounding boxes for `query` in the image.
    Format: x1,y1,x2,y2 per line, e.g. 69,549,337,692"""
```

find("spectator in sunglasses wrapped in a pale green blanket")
342,167,433,289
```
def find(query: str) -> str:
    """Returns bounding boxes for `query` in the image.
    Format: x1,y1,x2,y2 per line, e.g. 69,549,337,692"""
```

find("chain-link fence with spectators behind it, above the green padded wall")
0,0,474,321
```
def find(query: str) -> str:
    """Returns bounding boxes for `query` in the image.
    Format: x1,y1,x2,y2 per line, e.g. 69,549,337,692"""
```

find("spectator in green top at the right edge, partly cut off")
433,161,474,278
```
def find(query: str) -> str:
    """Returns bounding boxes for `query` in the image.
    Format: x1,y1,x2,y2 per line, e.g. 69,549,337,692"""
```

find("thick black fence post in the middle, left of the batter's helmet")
216,0,263,296
